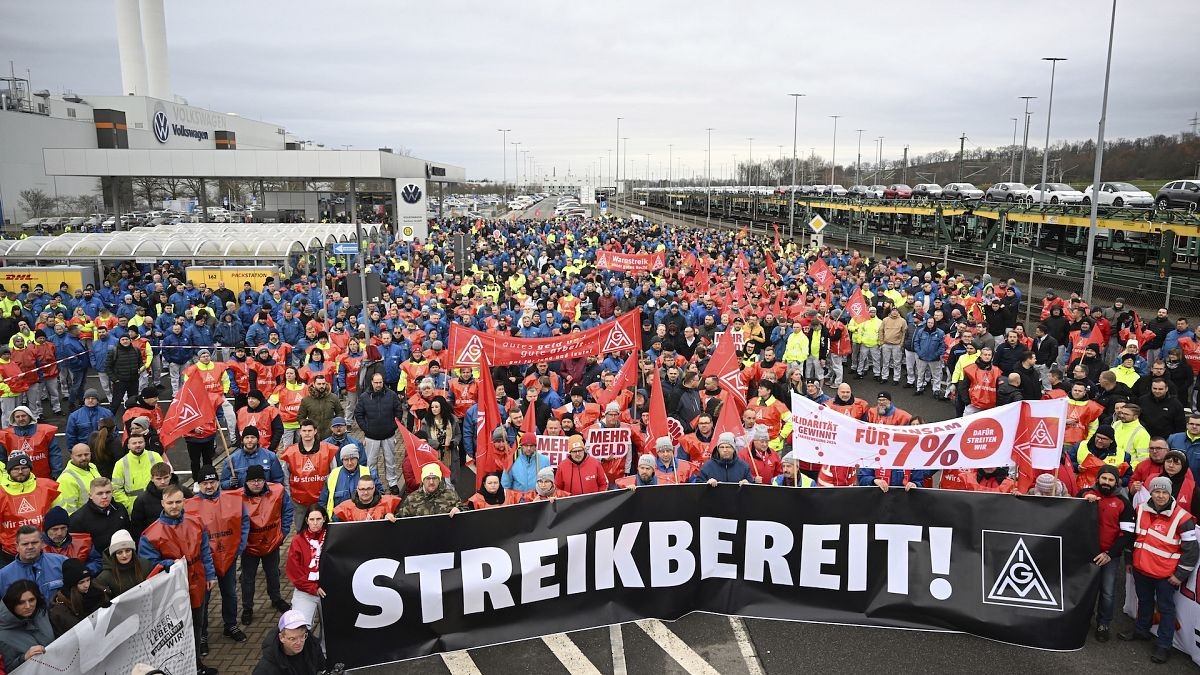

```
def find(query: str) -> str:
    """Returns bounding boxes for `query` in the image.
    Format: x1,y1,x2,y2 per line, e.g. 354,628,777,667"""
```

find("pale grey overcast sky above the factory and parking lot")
0,0,1200,180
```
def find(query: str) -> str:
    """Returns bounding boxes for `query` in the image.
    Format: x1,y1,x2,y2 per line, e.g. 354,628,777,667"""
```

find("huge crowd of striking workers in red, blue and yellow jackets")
0,211,1200,673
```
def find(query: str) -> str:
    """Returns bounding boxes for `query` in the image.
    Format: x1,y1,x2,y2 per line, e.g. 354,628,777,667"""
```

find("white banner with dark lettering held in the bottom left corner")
8,561,196,675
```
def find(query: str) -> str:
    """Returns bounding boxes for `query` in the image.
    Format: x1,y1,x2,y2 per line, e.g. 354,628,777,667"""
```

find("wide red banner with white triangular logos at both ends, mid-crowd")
449,310,642,368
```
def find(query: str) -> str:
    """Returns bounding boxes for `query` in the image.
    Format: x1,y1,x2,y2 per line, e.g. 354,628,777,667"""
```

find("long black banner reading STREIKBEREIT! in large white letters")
320,484,1098,667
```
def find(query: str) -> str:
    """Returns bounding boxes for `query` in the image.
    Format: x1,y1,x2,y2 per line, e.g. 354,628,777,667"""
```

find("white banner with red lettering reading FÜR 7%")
792,394,1067,471
